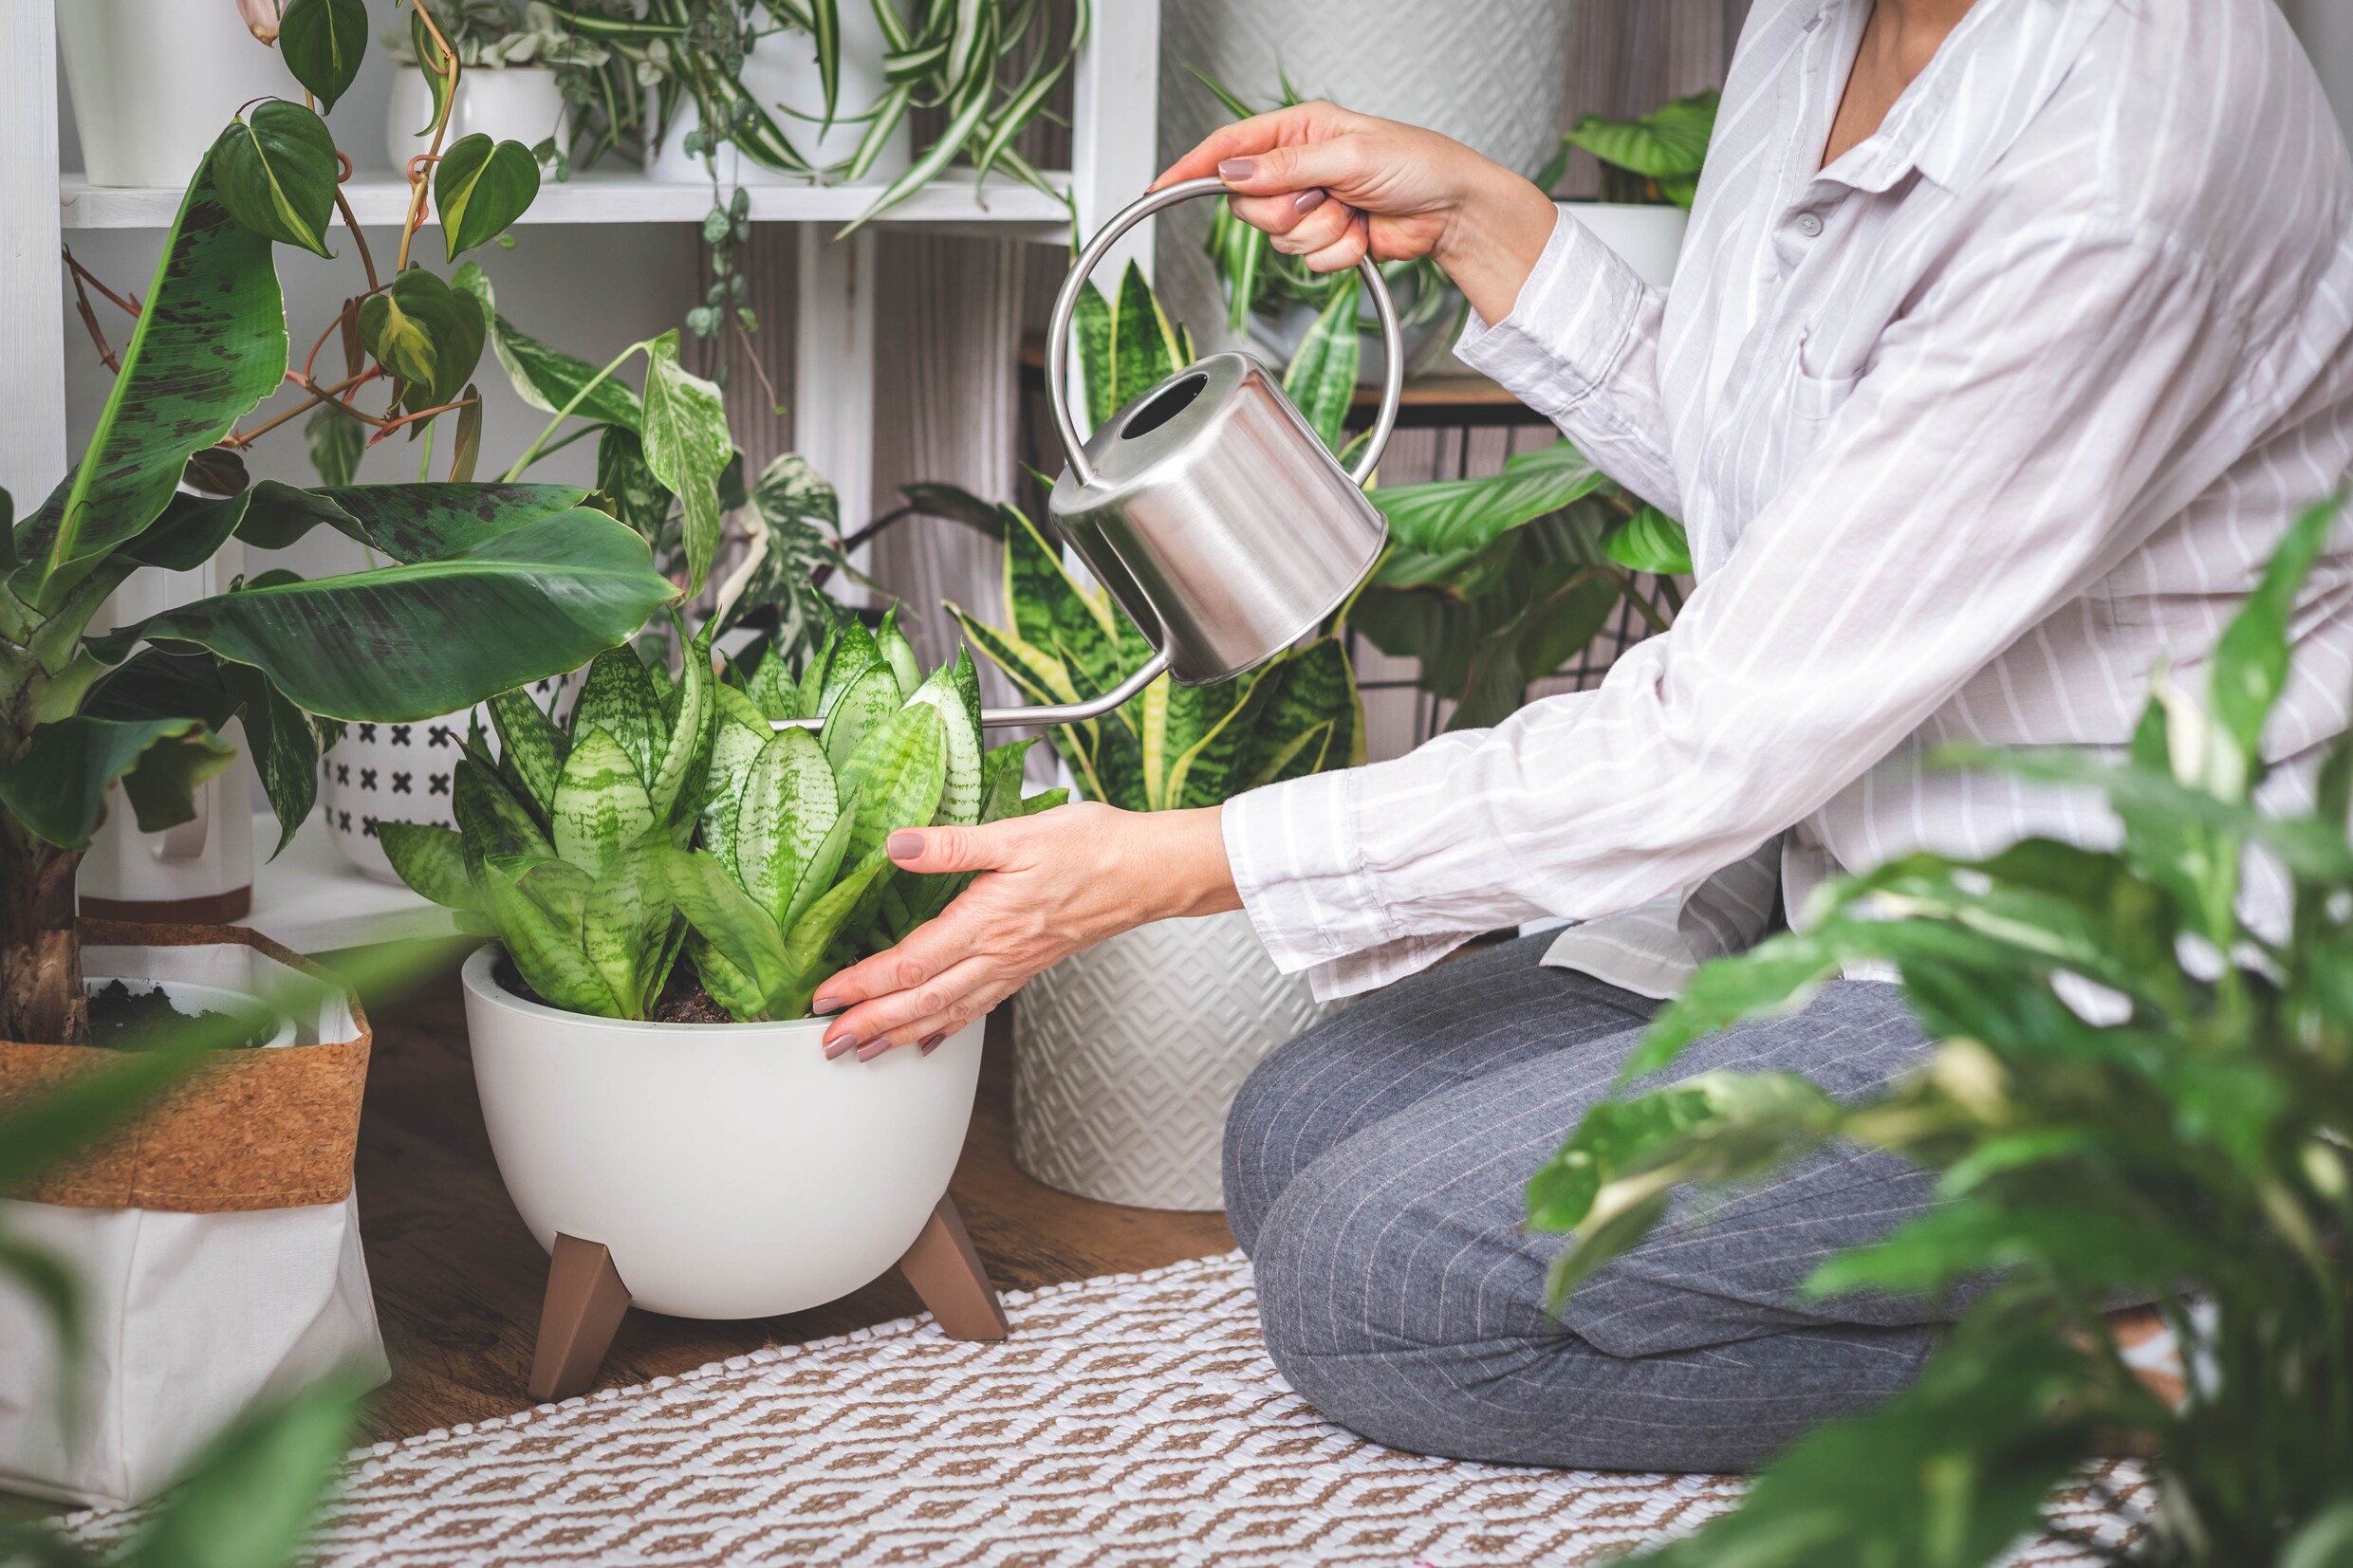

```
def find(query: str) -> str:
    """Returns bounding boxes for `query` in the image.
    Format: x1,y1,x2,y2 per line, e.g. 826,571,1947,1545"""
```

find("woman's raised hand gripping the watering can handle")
1153,103,1558,323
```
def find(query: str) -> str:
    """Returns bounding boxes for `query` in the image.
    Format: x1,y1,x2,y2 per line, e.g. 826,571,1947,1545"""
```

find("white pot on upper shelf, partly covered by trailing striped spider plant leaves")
645,5,913,186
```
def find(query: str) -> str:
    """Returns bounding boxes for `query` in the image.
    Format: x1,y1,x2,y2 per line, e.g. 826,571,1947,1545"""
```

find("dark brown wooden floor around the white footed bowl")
358,945,1233,1441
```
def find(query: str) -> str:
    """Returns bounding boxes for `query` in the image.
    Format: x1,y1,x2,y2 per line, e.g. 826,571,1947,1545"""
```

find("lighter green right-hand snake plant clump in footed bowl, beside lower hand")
668,620,1064,1023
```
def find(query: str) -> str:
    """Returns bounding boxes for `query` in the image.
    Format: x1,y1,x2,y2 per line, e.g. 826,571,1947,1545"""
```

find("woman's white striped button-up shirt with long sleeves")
1224,0,2353,997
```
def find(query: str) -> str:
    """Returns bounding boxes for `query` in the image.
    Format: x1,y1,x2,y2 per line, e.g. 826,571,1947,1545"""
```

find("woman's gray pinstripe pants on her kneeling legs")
1226,935,1943,1469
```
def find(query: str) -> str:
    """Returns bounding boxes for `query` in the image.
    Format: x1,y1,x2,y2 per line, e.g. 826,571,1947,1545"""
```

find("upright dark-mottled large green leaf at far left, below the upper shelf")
37,160,287,609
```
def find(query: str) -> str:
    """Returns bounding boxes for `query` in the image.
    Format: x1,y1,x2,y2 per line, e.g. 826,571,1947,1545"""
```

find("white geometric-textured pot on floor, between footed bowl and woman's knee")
1014,910,1325,1210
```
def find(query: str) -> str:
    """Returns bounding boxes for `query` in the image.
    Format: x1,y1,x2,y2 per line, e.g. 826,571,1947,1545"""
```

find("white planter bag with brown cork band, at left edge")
0,921,388,1504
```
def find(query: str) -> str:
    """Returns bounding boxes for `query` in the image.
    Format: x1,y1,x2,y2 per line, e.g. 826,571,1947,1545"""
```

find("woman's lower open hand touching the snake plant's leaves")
814,802,1242,1061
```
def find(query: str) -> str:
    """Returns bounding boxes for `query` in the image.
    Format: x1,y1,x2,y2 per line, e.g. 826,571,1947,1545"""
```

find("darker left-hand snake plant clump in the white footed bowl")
379,630,717,1018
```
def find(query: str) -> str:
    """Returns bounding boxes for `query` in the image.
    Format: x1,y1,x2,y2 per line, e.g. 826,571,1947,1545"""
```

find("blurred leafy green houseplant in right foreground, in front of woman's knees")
1528,495,2353,1568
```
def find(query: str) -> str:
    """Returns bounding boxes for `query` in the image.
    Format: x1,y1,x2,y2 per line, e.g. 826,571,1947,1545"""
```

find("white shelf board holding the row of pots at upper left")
57,172,1070,240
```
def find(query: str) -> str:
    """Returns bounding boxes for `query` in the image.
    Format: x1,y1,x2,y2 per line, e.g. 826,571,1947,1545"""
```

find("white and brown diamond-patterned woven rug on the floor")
64,1253,2143,1568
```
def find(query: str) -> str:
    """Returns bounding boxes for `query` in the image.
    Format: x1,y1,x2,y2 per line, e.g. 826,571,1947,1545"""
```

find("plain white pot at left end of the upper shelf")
56,0,301,191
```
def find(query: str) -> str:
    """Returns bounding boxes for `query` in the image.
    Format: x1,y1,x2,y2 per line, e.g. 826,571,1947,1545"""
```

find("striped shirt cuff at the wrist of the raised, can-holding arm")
1454,207,1649,421
